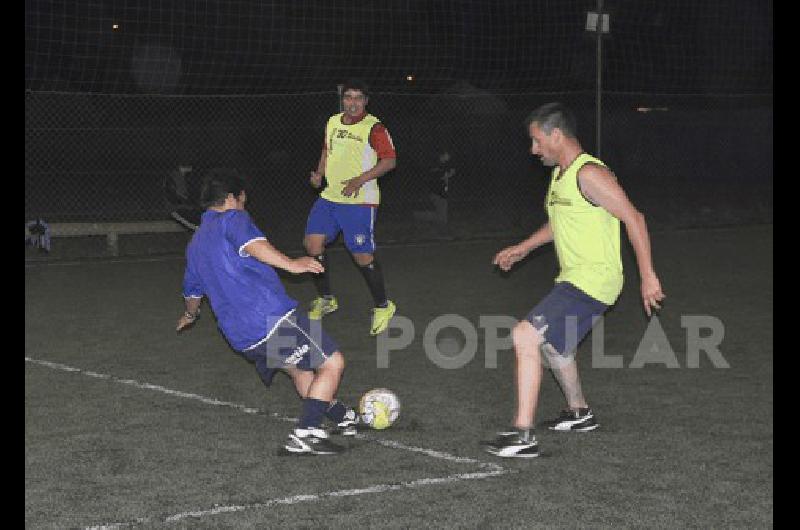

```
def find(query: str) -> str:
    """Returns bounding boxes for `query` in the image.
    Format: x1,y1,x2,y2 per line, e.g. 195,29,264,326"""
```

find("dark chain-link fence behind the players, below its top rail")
25,90,772,251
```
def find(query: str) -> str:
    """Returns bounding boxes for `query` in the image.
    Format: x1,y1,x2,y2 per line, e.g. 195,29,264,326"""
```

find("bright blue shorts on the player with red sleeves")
306,197,377,254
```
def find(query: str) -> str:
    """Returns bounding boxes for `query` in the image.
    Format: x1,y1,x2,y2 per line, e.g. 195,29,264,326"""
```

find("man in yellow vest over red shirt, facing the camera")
303,80,397,335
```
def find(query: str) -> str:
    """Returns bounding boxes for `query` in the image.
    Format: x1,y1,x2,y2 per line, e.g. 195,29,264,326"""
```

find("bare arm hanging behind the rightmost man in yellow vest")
578,164,665,316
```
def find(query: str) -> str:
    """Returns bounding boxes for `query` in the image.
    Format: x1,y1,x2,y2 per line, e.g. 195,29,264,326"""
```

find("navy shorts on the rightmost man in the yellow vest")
525,282,608,355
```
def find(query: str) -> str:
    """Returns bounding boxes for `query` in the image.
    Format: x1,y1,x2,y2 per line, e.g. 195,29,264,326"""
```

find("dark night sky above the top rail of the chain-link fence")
25,0,773,94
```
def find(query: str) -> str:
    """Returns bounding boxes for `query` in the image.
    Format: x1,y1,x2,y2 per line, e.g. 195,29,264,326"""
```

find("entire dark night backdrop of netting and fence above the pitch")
25,0,773,259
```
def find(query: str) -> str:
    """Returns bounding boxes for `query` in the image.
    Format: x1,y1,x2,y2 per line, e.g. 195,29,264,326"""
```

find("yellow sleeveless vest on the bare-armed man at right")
545,153,623,305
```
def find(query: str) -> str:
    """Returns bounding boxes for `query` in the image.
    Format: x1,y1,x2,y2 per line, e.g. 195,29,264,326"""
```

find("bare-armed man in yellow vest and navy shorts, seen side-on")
485,103,665,458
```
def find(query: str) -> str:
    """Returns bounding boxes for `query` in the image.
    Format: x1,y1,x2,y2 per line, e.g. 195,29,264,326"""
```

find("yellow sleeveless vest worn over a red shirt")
320,113,381,204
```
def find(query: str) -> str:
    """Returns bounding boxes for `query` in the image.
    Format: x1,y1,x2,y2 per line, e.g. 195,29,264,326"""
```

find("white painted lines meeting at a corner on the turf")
25,357,514,529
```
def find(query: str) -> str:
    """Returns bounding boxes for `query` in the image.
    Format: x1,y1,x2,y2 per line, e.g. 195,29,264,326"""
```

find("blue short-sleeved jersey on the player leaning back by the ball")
183,210,297,351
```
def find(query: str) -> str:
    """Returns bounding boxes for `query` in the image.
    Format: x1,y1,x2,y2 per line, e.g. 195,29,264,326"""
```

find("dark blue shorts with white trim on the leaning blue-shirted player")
242,313,339,386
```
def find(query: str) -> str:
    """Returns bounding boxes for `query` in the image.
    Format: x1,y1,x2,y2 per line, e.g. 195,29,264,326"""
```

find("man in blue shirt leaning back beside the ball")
177,169,358,454
